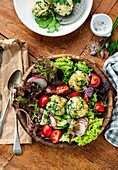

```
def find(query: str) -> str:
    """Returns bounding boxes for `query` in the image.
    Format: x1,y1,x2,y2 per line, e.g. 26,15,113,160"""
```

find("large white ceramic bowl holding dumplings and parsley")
14,0,93,37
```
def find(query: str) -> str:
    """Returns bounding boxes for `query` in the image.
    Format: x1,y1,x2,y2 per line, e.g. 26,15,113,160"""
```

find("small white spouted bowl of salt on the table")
90,14,113,37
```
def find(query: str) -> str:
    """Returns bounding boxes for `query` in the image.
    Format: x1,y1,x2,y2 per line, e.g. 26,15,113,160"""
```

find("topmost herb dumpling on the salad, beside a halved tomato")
68,71,90,92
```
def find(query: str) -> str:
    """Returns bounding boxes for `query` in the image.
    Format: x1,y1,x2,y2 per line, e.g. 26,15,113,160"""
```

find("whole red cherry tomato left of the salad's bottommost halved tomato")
41,125,52,138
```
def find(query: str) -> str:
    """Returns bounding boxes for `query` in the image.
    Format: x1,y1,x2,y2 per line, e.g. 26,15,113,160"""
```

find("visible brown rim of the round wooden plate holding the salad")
18,54,113,149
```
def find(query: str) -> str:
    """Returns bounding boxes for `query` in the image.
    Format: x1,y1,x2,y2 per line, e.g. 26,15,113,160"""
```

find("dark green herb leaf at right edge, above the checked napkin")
108,38,118,55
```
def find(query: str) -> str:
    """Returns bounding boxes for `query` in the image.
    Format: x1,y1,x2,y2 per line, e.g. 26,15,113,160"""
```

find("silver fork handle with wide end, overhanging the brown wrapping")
13,114,22,155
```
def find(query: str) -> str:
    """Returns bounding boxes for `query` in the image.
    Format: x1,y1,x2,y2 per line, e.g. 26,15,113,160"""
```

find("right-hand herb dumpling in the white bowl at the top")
52,0,73,16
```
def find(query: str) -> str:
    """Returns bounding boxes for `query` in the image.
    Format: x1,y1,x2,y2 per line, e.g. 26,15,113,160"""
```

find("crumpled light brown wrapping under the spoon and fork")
0,39,32,144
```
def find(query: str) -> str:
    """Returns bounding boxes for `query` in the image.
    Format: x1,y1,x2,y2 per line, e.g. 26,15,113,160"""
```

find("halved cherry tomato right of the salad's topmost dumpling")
90,74,100,88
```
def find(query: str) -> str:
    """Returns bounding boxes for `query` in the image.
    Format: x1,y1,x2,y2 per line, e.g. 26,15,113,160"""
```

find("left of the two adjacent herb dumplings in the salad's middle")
46,95,67,115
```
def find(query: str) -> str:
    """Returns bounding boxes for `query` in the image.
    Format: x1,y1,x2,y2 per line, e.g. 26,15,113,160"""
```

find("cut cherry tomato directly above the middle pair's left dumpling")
56,84,69,96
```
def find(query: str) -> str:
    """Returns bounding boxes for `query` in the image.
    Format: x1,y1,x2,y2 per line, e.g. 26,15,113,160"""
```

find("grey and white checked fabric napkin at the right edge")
103,52,118,147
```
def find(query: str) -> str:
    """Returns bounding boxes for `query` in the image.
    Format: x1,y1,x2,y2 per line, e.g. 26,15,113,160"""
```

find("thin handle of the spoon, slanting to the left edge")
0,94,11,138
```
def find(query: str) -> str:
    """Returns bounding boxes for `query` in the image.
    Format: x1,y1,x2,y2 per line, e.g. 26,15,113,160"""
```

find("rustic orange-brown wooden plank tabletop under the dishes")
0,0,118,170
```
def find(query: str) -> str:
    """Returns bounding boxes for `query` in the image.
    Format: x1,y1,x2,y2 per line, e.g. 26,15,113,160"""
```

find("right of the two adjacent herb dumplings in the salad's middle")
67,97,88,118
